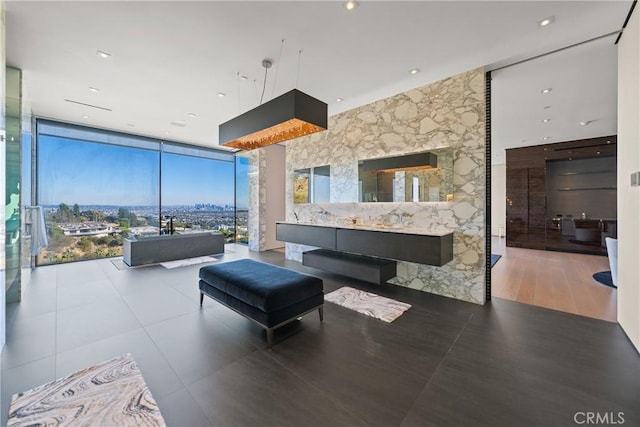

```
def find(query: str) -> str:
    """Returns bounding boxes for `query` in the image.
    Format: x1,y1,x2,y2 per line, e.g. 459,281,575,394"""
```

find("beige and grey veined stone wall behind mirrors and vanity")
286,68,485,304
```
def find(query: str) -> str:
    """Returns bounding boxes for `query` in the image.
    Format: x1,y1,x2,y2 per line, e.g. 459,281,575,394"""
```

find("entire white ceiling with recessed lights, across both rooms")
6,0,631,163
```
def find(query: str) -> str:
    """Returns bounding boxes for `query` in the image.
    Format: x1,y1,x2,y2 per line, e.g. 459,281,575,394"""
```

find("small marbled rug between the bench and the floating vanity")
324,286,411,323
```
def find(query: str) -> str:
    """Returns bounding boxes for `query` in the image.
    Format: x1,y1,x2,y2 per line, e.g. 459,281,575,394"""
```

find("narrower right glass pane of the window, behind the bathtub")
161,152,235,242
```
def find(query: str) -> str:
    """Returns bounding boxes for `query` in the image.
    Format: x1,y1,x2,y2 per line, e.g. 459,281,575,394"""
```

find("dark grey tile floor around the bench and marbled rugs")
2,250,640,427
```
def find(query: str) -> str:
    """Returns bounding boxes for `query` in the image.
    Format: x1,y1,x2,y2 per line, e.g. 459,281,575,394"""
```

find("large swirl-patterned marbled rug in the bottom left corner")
7,354,166,427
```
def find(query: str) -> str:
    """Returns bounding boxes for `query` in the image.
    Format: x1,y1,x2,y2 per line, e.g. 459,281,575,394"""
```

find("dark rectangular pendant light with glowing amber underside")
218,89,327,150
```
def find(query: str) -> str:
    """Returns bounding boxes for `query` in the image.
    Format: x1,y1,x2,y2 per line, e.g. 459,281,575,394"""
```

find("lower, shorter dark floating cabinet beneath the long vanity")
302,249,396,285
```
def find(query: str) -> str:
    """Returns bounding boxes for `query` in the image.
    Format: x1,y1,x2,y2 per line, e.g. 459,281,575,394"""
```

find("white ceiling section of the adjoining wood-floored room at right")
491,36,618,164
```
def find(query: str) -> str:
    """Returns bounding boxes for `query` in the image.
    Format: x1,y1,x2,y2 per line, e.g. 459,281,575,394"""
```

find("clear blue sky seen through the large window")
38,135,246,206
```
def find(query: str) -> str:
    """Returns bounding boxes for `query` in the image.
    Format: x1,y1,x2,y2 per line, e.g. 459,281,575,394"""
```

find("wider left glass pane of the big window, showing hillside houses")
37,135,160,265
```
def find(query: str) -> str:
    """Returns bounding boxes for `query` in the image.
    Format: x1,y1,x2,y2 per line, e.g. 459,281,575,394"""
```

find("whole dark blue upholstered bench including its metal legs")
199,259,324,348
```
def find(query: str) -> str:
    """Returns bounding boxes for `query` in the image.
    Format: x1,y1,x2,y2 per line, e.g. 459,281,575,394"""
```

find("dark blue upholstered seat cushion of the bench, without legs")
200,259,322,313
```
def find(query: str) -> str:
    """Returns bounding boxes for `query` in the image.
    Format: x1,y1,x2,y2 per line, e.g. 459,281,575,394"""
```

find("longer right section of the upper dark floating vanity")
336,228,453,266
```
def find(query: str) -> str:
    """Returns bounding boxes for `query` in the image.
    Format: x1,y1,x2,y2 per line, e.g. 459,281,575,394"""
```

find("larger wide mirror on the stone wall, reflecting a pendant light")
358,148,453,202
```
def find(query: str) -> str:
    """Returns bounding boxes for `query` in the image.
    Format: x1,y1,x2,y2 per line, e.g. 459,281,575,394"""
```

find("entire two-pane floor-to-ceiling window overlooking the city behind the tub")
36,120,236,265
